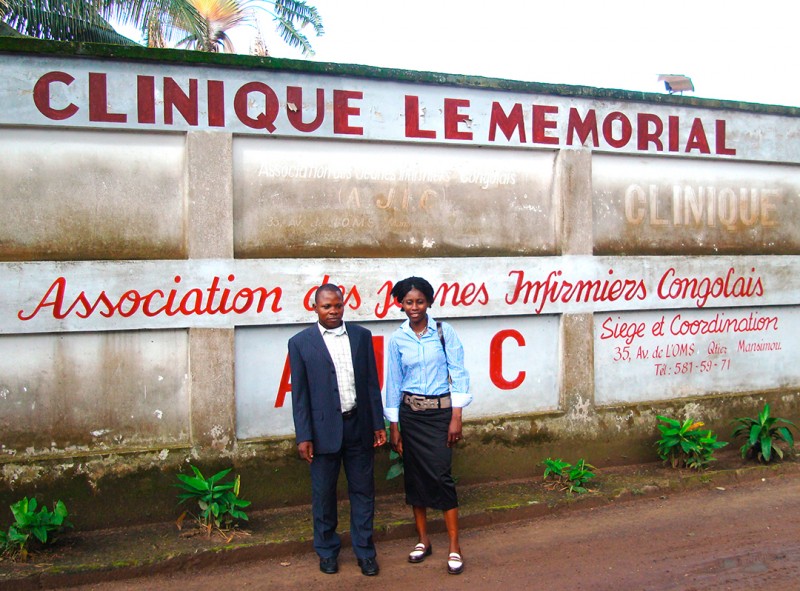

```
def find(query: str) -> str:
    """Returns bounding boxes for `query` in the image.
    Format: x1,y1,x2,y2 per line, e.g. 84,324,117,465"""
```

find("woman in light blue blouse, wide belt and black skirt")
384,277,472,574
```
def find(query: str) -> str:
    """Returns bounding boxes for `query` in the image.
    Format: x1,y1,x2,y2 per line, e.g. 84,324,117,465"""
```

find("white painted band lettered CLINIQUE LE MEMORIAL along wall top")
0,55,800,163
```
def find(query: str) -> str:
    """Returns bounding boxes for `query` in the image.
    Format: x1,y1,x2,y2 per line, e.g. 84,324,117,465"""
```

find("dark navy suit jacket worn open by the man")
289,322,384,453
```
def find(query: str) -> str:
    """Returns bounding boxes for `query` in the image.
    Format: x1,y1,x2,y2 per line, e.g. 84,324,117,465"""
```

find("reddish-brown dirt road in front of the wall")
64,477,800,591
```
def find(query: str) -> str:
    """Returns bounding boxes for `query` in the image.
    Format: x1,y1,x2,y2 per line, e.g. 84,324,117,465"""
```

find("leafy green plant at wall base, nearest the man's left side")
176,464,250,534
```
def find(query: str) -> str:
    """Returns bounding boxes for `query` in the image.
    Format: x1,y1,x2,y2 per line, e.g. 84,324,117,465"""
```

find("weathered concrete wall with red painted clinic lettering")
0,40,800,527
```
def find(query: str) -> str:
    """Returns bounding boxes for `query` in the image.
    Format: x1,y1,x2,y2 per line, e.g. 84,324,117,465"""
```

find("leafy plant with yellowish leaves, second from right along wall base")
656,415,728,470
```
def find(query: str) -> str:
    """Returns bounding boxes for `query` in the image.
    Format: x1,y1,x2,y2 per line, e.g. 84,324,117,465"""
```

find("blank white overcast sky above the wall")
120,0,800,106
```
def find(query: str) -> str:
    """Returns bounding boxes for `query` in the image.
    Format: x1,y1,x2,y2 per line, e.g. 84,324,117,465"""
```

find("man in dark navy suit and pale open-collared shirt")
289,283,386,576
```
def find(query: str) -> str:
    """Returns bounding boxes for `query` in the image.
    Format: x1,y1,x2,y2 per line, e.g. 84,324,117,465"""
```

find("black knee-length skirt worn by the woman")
400,403,458,511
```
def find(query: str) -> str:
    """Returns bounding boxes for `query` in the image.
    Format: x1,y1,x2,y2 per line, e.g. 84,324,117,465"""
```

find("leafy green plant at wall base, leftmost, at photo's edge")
0,497,72,560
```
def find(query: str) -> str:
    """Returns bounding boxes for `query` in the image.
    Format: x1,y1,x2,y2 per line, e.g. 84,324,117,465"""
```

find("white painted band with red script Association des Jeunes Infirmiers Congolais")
0,256,800,334
